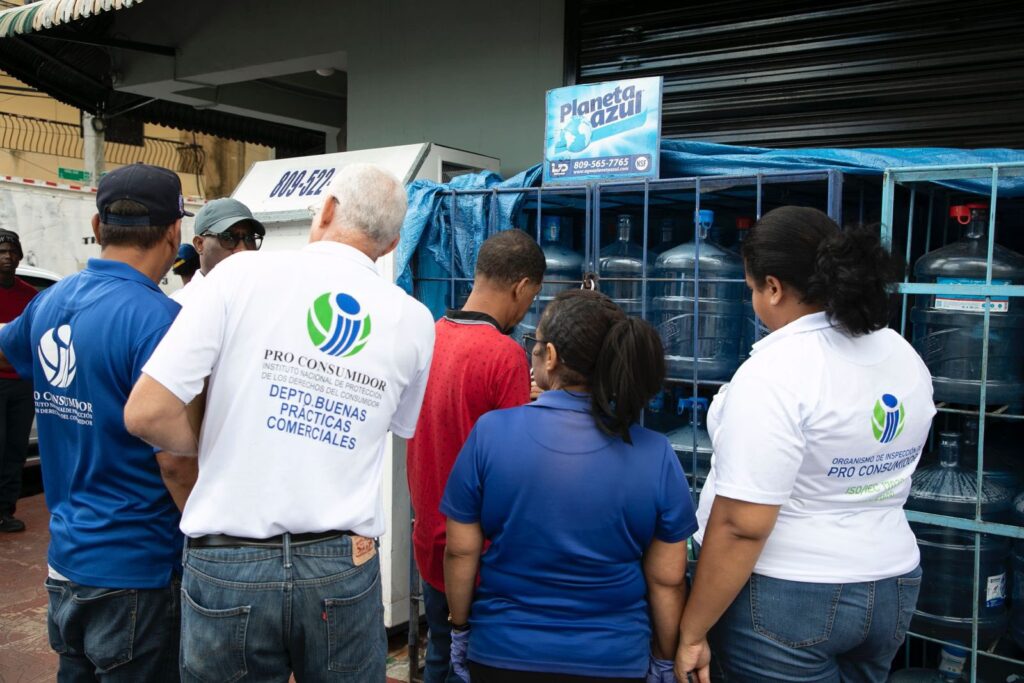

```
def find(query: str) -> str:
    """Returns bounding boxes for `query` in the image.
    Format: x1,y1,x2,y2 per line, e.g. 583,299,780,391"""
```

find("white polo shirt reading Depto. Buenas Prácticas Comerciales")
142,242,434,539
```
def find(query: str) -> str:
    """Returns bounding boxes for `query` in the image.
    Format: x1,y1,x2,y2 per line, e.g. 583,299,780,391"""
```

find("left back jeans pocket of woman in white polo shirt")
750,574,843,648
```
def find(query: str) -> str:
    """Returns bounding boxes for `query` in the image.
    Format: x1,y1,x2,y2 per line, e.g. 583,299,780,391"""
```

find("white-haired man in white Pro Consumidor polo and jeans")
125,165,434,681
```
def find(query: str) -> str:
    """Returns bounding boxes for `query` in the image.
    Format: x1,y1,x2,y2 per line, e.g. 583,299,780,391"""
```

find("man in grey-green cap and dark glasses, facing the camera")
171,197,266,306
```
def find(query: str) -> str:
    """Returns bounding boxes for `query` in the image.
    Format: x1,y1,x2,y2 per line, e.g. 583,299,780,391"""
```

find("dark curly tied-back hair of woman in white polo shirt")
743,206,900,336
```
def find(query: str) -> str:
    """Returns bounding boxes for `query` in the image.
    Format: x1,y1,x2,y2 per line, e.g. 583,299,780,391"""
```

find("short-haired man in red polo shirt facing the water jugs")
408,229,545,683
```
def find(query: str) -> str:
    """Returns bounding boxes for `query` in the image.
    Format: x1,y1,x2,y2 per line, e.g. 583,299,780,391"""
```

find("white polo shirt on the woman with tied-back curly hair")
695,313,935,584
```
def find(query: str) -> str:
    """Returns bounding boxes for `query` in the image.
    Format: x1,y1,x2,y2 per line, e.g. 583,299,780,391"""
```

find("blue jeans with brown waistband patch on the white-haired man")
180,536,387,683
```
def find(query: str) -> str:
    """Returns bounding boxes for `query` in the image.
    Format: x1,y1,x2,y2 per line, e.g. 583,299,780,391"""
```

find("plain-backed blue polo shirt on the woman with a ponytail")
440,391,697,678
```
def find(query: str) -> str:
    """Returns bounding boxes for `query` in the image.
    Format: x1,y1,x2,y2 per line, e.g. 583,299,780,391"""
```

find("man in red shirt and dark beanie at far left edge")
0,229,36,532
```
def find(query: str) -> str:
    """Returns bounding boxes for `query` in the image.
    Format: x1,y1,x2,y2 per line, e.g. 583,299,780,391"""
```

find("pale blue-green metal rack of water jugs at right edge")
881,163,1024,682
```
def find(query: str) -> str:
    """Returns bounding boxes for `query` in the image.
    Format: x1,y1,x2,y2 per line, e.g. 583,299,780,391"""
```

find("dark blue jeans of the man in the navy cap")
46,579,180,683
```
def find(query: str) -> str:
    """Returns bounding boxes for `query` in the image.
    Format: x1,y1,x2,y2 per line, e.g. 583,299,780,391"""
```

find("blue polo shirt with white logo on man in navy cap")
0,259,181,588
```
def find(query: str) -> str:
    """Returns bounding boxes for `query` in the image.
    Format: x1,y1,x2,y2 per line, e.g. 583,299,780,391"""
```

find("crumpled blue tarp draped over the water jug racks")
395,140,1024,299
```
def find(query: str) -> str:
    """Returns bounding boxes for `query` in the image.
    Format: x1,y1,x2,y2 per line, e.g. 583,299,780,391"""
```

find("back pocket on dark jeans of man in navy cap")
68,585,138,674
